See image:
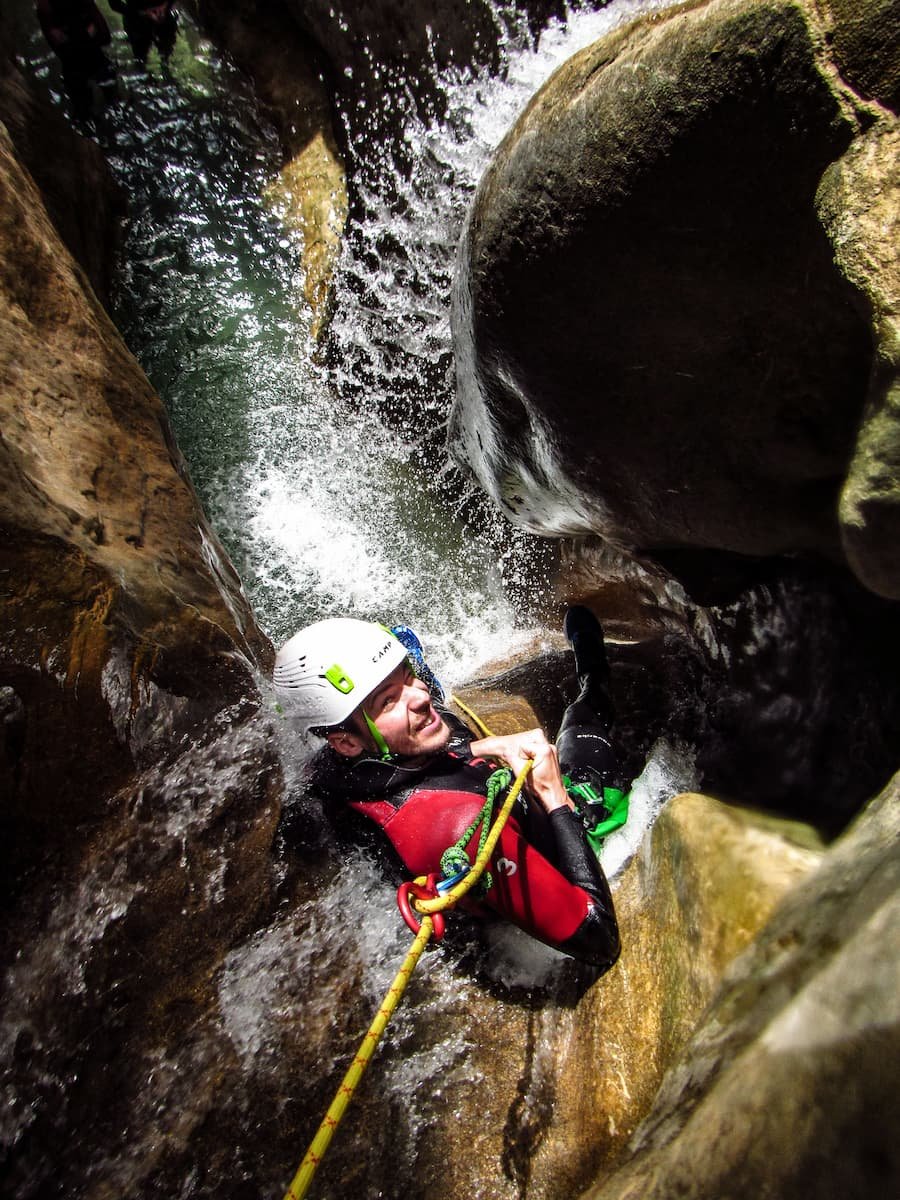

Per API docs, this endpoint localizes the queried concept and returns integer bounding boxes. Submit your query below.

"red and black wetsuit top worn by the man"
[316,709,619,970]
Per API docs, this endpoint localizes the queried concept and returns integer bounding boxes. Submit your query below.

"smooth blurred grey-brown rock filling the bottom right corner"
[586,779,900,1200]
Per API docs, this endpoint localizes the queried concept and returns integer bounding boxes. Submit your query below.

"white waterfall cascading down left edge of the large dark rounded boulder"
[332,0,691,427]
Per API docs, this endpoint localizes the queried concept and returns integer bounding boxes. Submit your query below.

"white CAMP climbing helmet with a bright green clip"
[274,617,407,730]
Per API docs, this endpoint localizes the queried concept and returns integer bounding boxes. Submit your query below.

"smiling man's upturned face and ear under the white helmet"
[329,662,450,756]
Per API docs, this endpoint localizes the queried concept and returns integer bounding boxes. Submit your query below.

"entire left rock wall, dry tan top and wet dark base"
[0,87,282,1196]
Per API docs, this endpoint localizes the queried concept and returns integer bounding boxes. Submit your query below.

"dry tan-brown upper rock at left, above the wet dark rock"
[0,121,270,878]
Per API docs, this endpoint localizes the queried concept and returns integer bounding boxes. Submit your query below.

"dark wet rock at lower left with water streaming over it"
[0,704,281,1200]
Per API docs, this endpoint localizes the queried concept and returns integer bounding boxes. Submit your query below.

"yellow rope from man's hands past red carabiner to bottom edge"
[284,758,532,1200]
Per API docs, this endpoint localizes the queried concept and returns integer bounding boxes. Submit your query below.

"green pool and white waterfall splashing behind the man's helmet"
[19,2,681,683]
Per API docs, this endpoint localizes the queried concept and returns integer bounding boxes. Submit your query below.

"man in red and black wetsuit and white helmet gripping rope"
[275,607,619,971]
